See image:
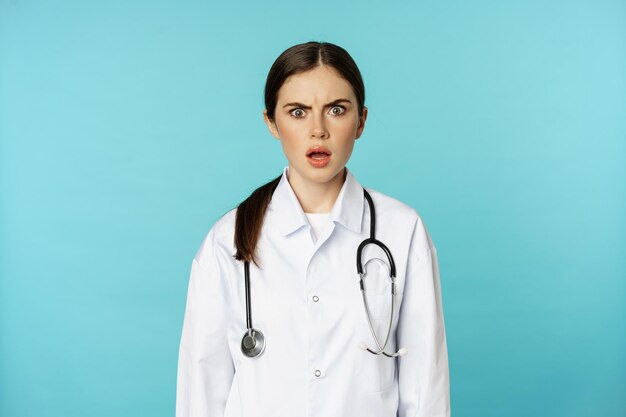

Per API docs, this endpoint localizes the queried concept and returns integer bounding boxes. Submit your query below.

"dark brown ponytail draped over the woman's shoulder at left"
[234,174,282,267]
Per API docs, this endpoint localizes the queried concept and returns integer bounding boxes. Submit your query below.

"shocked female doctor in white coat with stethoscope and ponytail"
[176,42,450,417]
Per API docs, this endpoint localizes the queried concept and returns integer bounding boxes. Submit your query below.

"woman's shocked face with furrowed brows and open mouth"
[263,66,367,184]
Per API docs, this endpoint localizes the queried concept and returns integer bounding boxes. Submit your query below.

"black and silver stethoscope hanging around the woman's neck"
[241,188,407,358]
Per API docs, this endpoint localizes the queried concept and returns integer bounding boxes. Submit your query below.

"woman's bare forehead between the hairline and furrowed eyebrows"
[278,66,354,102]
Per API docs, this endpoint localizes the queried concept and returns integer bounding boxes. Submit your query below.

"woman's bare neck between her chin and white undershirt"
[287,166,347,213]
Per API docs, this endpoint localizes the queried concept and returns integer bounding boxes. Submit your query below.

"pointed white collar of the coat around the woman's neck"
[268,165,365,236]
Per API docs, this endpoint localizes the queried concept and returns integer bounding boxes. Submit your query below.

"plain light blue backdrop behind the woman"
[0,0,626,417]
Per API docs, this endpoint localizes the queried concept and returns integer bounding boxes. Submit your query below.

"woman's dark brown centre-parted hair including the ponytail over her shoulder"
[234,41,365,267]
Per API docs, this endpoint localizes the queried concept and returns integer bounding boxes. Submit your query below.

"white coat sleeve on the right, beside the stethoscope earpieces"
[397,217,450,417]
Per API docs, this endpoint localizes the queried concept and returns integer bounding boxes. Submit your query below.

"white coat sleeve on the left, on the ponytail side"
[176,229,234,417]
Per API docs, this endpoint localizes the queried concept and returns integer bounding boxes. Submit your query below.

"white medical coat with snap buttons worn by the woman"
[176,166,450,417]
